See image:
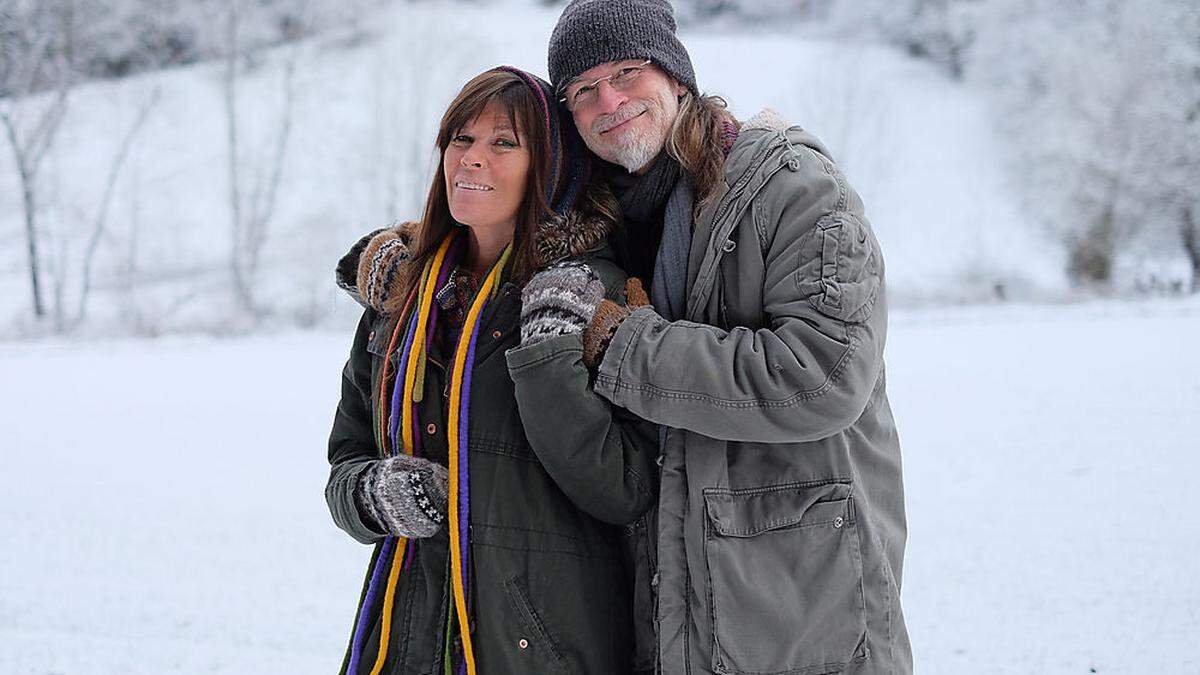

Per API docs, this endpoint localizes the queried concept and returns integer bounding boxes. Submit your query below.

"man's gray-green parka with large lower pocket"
[508,112,912,675]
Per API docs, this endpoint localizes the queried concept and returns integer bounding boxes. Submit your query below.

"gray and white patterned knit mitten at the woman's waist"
[354,455,450,539]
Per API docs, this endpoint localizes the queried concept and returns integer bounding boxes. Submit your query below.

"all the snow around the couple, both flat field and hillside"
[0,4,1200,675]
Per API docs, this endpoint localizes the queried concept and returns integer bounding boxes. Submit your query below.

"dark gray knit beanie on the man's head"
[548,0,700,95]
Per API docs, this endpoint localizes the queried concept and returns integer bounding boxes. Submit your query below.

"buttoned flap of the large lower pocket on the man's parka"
[704,482,853,537]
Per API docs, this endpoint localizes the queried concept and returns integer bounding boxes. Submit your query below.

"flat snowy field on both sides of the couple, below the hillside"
[0,303,1200,675]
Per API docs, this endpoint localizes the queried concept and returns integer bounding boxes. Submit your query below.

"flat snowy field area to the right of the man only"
[889,296,1200,674]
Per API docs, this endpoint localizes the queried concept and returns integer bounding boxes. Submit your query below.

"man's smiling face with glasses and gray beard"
[565,59,686,173]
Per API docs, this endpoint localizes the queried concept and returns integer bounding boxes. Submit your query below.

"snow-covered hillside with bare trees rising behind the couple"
[0,4,1063,334]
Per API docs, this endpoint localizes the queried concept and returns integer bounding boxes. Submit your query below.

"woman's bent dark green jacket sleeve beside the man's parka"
[506,265,659,525]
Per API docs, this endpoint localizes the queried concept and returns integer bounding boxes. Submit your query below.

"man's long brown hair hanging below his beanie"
[667,91,738,205]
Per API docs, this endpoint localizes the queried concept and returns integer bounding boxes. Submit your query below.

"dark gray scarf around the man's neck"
[612,151,692,321]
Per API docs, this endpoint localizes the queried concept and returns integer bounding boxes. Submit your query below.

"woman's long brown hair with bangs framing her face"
[404,68,552,294]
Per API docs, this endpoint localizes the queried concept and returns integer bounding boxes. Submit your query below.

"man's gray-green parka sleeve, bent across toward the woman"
[595,165,887,443]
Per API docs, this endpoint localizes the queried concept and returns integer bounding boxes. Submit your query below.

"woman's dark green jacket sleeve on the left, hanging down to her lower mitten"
[325,310,384,544]
